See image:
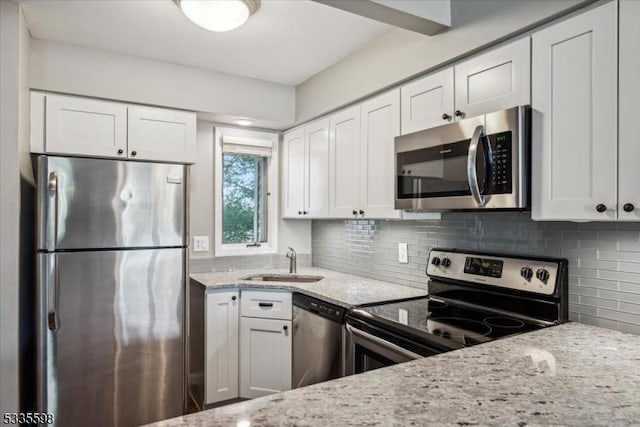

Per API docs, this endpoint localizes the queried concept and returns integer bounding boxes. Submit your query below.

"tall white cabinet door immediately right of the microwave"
[532,2,618,221]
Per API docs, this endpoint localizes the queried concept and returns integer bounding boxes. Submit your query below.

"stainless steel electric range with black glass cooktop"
[345,249,568,375]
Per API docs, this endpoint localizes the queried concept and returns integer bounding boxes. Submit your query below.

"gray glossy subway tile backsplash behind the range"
[312,212,640,334]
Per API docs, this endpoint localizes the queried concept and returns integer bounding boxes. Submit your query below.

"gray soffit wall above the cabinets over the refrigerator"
[31,39,295,128]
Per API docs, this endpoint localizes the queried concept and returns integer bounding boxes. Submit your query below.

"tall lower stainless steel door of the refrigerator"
[38,248,185,426]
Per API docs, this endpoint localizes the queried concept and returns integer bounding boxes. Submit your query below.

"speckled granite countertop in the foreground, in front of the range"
[148,323,640,427]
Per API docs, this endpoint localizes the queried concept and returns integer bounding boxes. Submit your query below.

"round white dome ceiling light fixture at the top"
[173,0,260,32]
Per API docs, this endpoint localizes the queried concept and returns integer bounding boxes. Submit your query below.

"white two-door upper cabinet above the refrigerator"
[31,92,196,163]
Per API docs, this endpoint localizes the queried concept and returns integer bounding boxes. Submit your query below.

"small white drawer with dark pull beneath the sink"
[240,291,291,320]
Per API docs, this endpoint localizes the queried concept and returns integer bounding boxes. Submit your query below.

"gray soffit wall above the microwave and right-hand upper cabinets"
[296,0,584,123]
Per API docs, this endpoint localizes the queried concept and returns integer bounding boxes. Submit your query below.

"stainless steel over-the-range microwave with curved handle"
[395,106,531,211]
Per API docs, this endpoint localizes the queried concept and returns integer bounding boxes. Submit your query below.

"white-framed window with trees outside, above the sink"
[214,128,278,256]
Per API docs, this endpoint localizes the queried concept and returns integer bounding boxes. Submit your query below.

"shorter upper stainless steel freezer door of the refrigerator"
[38,156,186,251]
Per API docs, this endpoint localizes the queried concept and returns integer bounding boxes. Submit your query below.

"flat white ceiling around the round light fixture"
[19,0,391,85]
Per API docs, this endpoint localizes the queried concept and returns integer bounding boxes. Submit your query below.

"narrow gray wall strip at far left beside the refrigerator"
[0,0,33,414]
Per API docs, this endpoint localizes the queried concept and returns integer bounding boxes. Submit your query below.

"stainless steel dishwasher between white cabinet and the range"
[293,293,345,388]
